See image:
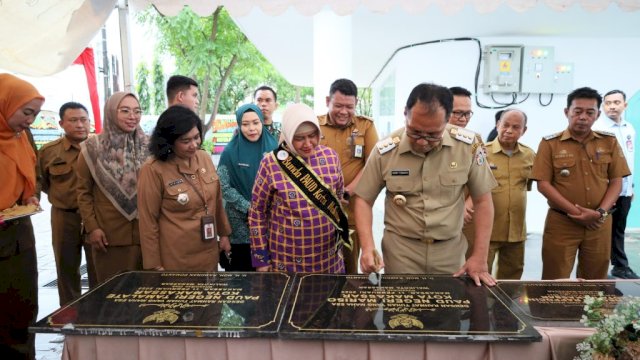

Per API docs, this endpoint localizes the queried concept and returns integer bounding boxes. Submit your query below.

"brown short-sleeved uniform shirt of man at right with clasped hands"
[531,129,630,209]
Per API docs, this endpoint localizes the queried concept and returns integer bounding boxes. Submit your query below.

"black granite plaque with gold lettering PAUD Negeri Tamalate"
[33,272,292,337]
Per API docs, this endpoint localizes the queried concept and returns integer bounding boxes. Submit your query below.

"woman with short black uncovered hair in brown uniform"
[138,105,231,272]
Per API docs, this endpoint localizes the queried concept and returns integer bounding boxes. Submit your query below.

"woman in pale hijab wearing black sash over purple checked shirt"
[249,104,349,273]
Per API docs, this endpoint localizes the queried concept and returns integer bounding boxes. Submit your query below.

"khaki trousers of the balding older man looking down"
[487,241,524,280]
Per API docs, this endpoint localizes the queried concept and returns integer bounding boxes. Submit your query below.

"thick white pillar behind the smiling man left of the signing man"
[313,11,353,114]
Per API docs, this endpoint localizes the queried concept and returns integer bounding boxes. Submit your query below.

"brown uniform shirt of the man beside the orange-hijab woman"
[38,136,80,210]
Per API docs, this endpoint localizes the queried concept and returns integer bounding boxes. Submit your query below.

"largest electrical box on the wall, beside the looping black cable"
[483,45,522,93]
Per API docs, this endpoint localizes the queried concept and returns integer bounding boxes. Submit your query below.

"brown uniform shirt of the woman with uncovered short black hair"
[138,151,231,271]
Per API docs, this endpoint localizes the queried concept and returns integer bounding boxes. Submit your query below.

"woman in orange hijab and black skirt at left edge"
[0,74,44,359]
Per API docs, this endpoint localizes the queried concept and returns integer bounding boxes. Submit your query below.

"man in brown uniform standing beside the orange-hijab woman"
[38,102,96,306]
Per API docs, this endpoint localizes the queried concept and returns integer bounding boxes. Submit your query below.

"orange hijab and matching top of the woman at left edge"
[0,74,44,210]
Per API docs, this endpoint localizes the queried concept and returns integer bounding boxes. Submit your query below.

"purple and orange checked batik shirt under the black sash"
[249,145,344,273]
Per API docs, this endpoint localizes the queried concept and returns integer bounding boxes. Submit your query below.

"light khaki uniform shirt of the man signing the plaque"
[356,125,496,240]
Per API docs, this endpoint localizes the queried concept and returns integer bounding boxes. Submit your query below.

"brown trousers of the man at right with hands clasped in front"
[542,209,611,280]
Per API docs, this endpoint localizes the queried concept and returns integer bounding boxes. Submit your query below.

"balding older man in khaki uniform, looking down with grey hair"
[487,109,536,280]
